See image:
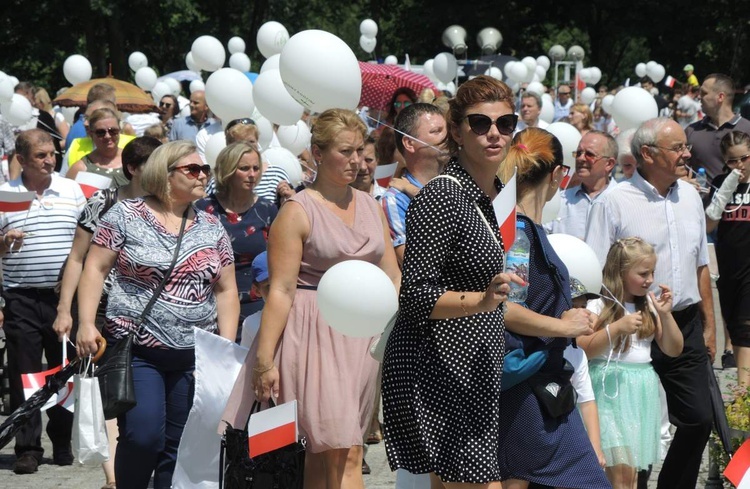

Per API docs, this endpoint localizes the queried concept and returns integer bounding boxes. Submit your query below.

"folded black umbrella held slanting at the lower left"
[0,336,107,449]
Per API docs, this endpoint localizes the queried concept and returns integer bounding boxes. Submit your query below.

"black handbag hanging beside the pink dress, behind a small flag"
[219,401,307,489]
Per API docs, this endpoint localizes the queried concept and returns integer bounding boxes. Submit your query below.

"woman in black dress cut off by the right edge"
[706,131,750,388]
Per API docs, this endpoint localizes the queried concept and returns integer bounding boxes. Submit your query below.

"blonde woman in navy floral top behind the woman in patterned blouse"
[196,142,278,332]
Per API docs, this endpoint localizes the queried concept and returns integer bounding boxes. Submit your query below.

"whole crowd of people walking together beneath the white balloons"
[0,61,750,489]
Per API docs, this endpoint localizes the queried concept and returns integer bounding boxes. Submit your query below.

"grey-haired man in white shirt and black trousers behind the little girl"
[586,118,716,488]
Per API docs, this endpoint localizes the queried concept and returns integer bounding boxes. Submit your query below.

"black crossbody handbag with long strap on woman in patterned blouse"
[94,207,190,419]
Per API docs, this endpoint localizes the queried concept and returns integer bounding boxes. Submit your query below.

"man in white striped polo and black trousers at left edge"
[0,129,86,474]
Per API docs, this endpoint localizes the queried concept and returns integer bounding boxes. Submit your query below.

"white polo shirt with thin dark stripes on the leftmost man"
[0,175,86,289]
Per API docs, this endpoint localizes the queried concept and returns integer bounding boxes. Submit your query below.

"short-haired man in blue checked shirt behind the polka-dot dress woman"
[381,103,448,266]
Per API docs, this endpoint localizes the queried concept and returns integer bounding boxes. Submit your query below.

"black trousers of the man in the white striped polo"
[3,288,75,459]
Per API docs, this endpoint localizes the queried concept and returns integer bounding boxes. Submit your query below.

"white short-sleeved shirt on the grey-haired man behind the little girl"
[586,171,708,311]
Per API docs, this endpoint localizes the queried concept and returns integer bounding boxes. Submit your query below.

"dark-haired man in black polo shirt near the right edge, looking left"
[685,73,750,182]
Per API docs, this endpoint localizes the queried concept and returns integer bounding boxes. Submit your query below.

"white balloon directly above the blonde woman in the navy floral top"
[206,68,255,121]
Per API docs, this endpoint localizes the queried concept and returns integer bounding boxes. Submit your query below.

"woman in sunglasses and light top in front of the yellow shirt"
[65,107,128,188]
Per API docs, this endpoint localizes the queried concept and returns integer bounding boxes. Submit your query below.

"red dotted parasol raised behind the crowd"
[359,61,441,110]
